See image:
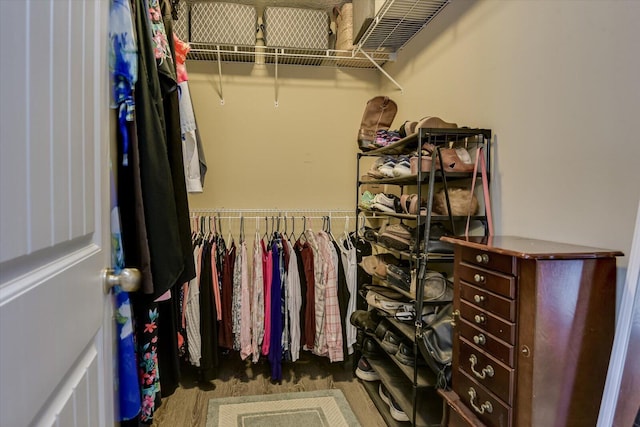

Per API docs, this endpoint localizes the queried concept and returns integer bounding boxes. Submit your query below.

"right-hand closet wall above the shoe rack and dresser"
[384,0,640,265]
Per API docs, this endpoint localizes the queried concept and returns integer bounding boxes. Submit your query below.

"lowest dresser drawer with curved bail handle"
[453,371,512,427]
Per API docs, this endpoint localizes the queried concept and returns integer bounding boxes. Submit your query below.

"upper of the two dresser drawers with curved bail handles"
[458,340,514,405]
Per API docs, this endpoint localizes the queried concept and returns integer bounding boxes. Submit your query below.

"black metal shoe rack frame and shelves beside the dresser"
[355,128,491,426]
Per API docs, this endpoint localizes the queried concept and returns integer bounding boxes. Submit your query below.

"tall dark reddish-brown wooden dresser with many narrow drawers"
[441,236,622,427]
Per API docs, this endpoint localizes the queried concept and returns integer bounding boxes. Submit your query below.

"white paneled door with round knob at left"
[0,0,114,427]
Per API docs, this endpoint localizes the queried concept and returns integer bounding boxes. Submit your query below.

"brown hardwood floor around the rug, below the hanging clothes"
[152,353,386,427]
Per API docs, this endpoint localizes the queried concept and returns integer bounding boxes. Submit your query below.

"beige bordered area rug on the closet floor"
[207,389,360,427]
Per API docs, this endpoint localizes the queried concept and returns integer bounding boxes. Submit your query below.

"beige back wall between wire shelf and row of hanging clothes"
[187,62,379,212]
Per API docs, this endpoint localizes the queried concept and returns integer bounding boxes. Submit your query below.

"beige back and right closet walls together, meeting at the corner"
[188,0,640,264]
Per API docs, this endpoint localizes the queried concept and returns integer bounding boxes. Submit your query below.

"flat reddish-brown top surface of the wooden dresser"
[441,236,624,259]
